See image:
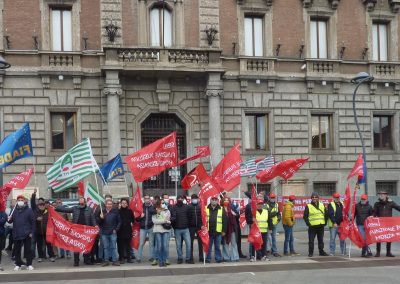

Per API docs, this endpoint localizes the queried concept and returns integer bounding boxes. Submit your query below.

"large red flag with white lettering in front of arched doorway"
[125,132,178,182]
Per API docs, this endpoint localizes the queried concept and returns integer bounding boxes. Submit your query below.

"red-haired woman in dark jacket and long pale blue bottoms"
[222,197,239,262]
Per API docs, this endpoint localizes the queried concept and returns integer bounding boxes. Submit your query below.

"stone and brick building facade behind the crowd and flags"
[0,0,400,197]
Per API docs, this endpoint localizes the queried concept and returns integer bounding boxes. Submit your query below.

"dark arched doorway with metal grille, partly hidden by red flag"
[141,113,187,195]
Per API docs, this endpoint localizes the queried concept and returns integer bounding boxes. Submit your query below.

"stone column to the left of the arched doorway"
[103,71,122,159]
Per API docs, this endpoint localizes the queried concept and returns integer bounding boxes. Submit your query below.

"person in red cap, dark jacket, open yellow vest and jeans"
[328,192,346,256]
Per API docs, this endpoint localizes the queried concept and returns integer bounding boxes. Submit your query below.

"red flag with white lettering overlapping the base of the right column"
[211,143,242,191]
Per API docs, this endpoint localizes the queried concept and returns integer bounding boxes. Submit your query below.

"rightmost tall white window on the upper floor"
[372,23,388,61]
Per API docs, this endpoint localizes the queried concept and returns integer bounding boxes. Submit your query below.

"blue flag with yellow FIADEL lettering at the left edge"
[0,123,33,169]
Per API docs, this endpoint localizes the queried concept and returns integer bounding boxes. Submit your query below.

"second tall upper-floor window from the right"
[310,19,328,58]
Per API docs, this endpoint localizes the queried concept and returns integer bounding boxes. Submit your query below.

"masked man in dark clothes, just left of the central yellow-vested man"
[189,194,204,262]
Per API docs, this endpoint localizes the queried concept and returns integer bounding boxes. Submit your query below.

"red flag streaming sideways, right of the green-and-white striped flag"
[256,157,310,182]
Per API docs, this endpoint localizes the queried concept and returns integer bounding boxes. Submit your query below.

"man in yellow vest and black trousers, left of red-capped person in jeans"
[303,192,328,257]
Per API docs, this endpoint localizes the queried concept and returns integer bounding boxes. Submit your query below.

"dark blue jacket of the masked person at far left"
[10,205,36,241]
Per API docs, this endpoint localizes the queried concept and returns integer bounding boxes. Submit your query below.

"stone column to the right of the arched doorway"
[206,73,223,167]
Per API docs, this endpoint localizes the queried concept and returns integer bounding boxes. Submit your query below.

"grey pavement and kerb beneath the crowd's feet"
[0,232,400,282]
